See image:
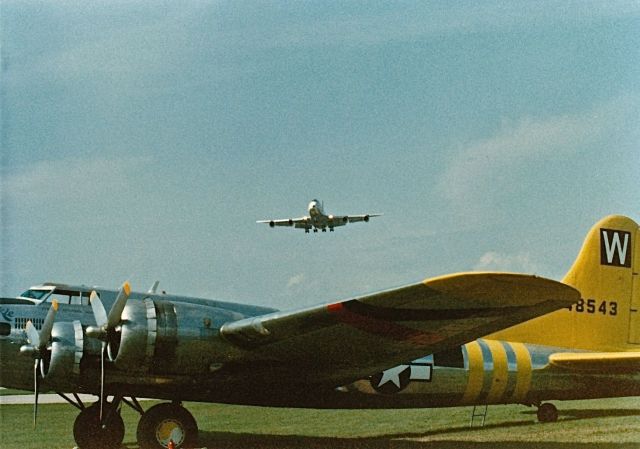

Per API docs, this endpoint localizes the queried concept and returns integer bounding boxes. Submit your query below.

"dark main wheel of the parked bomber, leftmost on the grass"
[73,403,124,449]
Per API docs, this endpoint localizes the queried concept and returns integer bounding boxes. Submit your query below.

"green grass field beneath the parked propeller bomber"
[0,398,640,449]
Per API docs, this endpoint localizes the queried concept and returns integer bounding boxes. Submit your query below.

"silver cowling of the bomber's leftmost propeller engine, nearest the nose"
[40,320,84,390]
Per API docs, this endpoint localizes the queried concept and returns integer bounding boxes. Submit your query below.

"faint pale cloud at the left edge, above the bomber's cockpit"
[2,156,149,232]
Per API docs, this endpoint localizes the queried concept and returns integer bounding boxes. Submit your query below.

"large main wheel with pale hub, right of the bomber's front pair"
[137,403,198,449]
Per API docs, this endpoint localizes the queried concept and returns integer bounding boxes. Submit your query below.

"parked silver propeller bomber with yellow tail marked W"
[0,216,640,449]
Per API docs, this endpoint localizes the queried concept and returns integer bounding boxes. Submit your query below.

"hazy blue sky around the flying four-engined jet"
[0,0,640,308]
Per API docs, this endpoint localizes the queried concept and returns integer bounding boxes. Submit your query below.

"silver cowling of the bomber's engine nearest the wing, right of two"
[107,298,157,372]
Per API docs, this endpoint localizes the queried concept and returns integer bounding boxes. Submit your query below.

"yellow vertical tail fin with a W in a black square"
[490,215,640,352]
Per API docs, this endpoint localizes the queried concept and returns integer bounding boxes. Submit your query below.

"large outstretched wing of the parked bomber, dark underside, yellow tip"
[220,273,580,386]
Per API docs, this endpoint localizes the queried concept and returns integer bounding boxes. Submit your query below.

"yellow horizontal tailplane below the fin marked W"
[549,352,640,374]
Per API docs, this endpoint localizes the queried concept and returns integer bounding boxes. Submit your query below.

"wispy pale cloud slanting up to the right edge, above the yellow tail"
[438,95,638,221]
